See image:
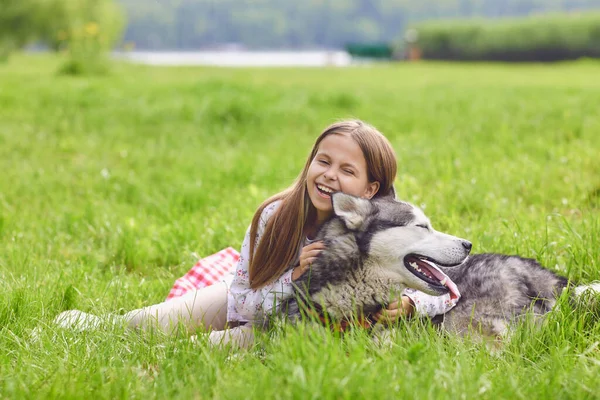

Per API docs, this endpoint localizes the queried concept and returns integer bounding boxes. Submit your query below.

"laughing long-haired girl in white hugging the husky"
[57,120,455,347]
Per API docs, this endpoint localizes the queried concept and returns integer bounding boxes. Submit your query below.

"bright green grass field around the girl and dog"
[0,55,600,399]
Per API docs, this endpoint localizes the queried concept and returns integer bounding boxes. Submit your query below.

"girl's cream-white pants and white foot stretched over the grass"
[55,282,254,348]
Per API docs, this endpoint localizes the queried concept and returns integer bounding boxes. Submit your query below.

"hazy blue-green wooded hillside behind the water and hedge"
[119,0,600,49]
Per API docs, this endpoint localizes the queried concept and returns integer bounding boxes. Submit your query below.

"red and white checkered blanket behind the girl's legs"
[167,247,240,300]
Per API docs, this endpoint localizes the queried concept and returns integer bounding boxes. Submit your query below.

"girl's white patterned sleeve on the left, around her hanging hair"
[227,202,294,321]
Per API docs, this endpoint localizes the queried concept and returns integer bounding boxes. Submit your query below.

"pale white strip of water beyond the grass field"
[114,50,352,67]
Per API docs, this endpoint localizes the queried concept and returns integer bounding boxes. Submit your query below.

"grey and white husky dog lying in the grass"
[283,193,596,336]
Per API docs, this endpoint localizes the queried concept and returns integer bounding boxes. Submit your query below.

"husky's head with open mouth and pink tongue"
[332,193,471,295]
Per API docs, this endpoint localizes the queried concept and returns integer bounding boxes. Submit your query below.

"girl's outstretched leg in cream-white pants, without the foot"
[123,282,227,333]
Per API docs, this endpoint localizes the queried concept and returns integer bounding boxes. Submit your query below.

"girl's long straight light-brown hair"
[249,120,397,289]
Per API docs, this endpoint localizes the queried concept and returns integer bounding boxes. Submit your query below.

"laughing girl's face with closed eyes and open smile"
[306,134,379,225]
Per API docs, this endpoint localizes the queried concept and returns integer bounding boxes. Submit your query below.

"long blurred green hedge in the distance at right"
[415,13,600,61]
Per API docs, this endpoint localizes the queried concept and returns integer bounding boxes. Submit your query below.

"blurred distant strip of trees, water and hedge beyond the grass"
[0,0,600,71]
